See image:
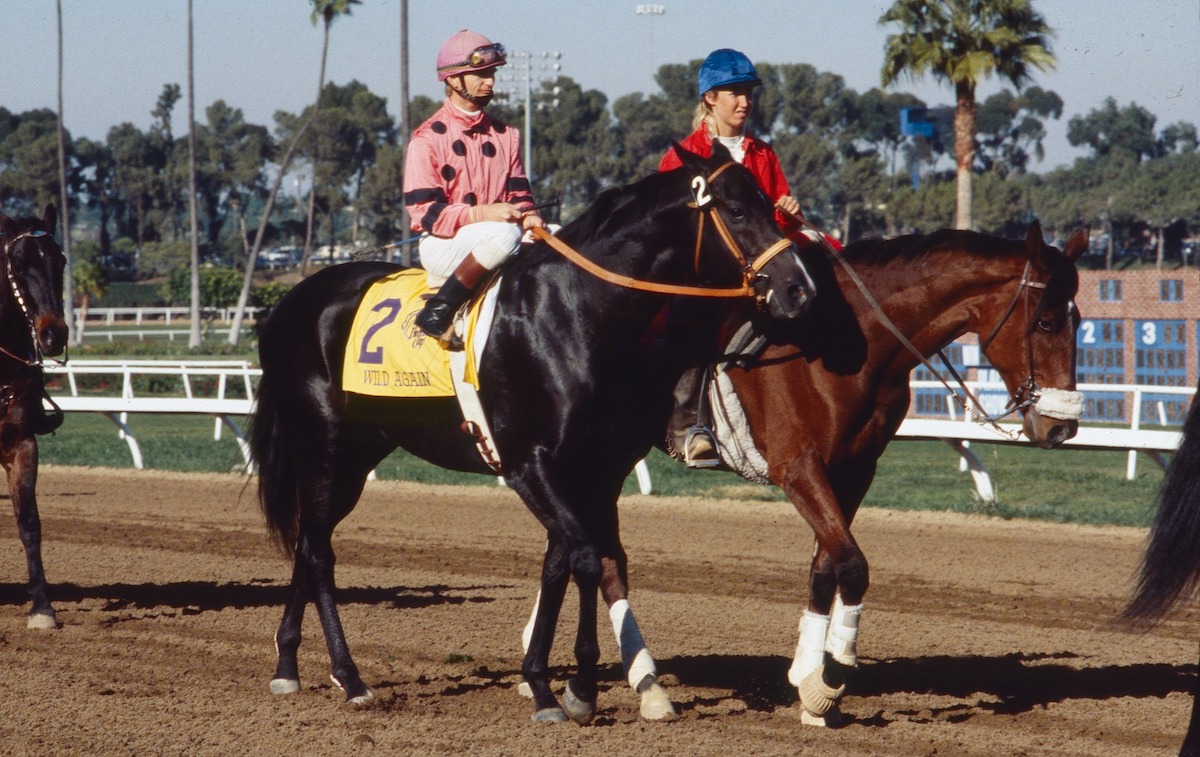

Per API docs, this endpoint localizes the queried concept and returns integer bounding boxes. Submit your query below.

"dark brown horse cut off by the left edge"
[0,204,67,629]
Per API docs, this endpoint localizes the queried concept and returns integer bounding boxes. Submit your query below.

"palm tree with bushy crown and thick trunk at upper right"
[880,0,1057,229]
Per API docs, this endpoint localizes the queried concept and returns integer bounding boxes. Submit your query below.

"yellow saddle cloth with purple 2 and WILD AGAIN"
[342,269,478,397]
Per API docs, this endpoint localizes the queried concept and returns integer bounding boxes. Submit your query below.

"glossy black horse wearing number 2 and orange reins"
[251,150,814,722]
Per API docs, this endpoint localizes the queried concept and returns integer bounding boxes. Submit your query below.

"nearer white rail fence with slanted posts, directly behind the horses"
[35,360,1195,501]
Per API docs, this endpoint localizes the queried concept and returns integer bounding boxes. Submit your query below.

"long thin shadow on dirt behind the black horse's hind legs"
[0,578,512,612]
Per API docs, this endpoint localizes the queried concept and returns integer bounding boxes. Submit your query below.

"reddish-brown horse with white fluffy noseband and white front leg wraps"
[544,222,1089,726]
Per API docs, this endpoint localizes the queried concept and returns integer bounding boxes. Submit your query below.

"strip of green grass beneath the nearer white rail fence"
[41,413,1163,525]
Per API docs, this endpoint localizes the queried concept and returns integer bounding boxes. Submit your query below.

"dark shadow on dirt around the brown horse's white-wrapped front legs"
[659,653,1196,725]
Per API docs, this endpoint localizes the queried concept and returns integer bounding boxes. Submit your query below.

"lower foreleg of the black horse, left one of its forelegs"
[521,539,570,722]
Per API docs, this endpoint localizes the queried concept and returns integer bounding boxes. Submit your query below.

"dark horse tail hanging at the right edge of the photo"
[1123,395,1200,625]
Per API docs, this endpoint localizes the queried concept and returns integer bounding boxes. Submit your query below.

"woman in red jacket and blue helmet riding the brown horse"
[659,48,841,468]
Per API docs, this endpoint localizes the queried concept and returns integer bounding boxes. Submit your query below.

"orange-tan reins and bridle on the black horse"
[533,161,792,311]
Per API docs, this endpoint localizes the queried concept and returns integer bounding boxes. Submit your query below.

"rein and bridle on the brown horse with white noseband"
[781,211,1046,441]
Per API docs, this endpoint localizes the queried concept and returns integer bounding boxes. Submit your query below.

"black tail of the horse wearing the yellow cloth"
[248,376,300,557]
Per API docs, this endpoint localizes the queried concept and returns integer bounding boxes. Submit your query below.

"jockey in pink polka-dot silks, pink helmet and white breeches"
[404,29,545,349]
